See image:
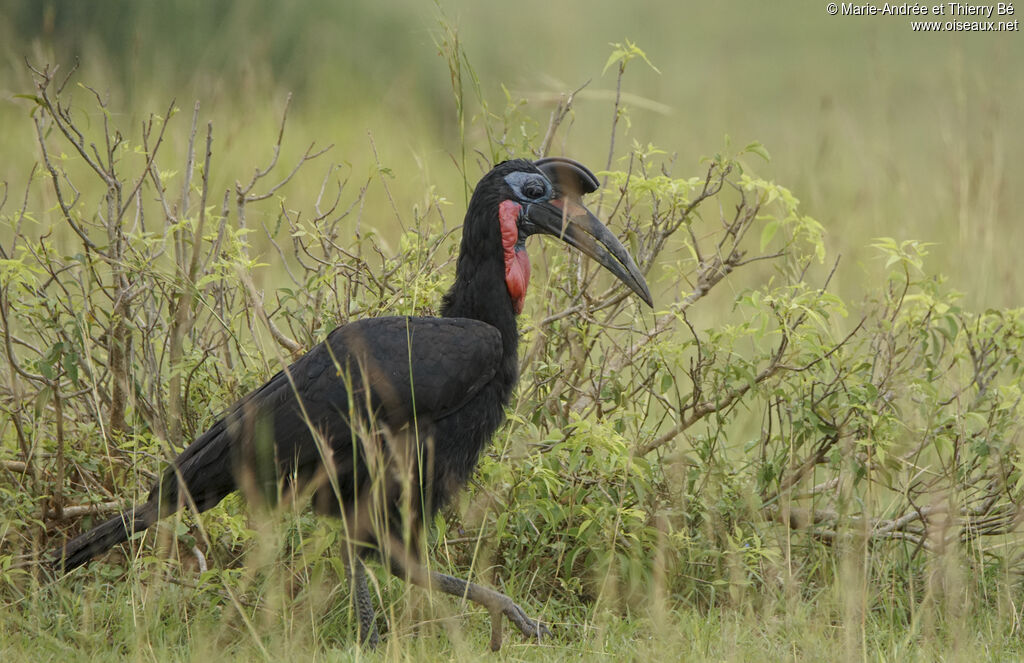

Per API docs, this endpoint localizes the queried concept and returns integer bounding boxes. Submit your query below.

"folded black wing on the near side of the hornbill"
[175,318,502,477]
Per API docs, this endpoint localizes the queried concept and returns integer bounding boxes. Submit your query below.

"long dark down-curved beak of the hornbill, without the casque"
[519,196,654,307]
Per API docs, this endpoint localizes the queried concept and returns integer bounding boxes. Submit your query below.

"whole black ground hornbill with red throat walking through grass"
[52,158,651,649]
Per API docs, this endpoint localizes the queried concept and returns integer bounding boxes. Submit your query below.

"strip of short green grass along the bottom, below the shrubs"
[0,570,1024,662]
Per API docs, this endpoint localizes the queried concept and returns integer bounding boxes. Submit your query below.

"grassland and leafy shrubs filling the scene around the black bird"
[0,2,1024,661]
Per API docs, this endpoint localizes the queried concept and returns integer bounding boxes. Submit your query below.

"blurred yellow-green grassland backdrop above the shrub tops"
[0,0,1024,309]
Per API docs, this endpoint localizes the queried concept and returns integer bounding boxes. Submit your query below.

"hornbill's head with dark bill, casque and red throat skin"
[467,157,653,314]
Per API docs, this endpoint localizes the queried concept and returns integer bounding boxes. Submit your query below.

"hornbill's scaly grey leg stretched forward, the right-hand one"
[387,537,551,652]
